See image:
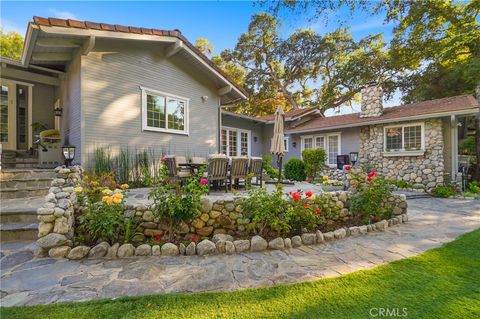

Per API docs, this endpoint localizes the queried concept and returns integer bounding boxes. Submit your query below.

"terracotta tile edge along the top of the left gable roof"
[33,16,248,96]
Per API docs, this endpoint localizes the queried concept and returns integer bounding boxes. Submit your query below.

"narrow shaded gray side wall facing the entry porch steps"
[60,56,83,163]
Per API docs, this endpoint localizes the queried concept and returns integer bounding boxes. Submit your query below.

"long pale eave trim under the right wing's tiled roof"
[286,108,480,134]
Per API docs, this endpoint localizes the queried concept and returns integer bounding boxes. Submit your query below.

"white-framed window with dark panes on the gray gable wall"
[142,88,189,134]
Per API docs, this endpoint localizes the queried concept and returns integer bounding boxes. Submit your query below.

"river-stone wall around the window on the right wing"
[359,119,444,188]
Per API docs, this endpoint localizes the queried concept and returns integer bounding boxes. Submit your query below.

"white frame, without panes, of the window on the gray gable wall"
[140,86,190,135]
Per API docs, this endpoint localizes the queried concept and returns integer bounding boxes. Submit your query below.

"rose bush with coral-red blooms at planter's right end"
[347,169,393,223]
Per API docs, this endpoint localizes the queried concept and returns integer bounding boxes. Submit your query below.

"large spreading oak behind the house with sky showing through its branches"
[221,14,395,115]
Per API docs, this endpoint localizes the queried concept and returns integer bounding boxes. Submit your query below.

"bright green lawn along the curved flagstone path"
[0,229,480,319]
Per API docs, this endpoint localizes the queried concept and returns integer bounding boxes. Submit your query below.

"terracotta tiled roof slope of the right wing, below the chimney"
[289,95,479,132]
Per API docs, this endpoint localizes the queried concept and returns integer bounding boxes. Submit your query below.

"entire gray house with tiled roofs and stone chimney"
[0,17,479,186]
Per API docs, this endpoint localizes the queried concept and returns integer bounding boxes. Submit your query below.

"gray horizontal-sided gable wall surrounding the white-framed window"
[82,40,219,165]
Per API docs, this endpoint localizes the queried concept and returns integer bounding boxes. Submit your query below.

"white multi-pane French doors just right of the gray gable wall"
[220,127,251,156]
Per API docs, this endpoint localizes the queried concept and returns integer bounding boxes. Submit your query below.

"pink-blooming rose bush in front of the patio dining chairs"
[148,166,208,240]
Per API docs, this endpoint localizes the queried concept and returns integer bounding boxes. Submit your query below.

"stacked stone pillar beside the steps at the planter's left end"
[37,166,83,257]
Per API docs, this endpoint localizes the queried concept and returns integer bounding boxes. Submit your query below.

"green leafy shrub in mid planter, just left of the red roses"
[241,184,292,236]
